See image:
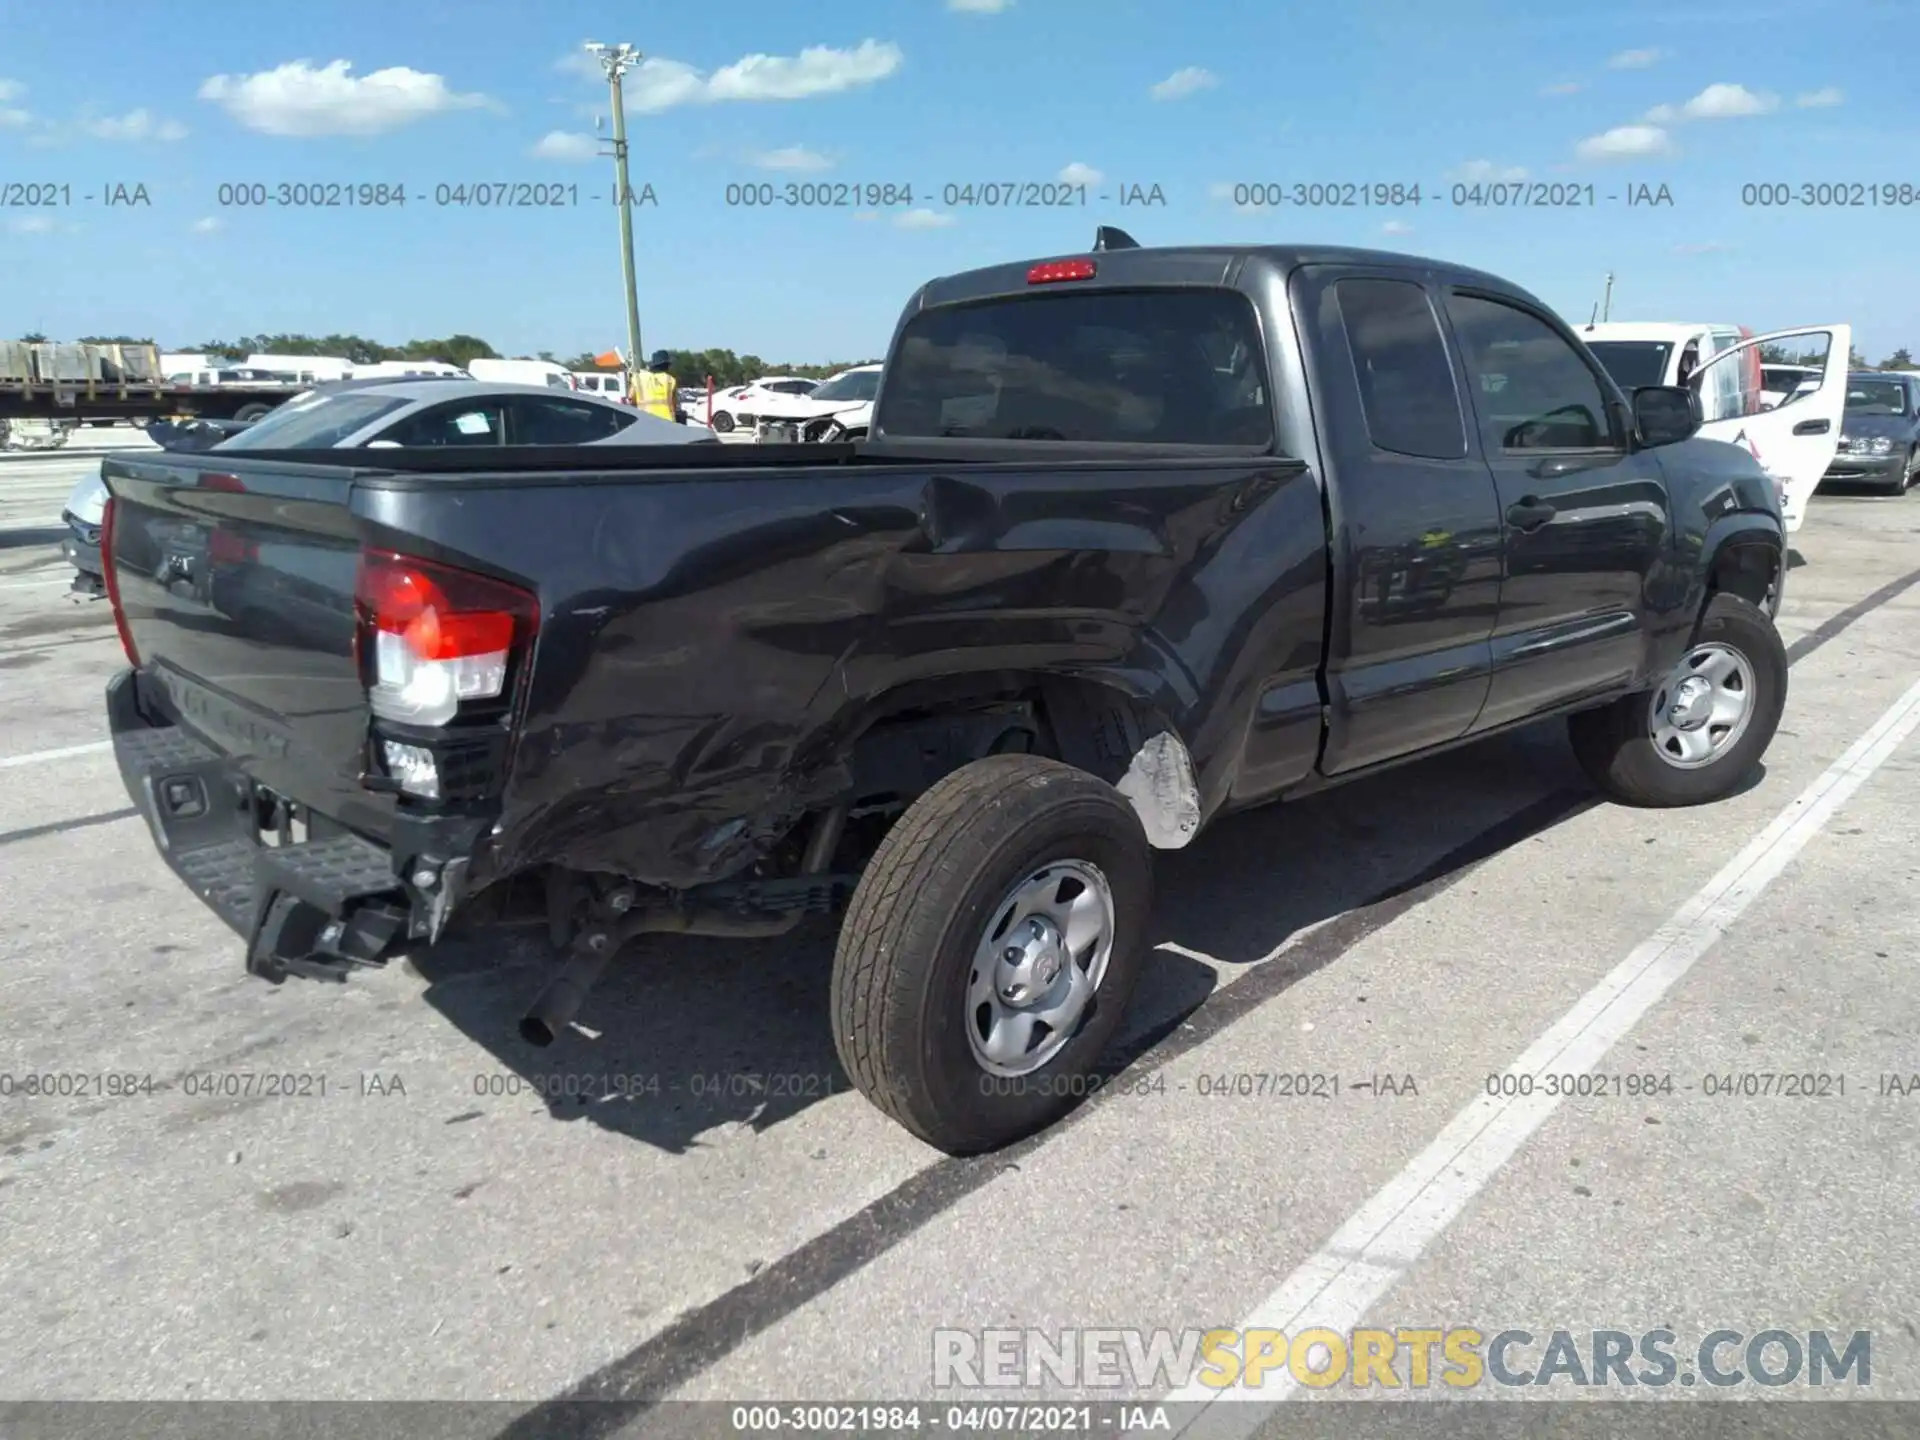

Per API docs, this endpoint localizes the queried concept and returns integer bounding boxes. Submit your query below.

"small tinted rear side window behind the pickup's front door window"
[1334,280,1467,461]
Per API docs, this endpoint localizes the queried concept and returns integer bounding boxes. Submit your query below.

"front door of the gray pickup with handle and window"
[1446,288,1668,730]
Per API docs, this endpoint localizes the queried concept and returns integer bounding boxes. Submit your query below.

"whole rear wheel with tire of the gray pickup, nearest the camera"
[831,755,1152,1154]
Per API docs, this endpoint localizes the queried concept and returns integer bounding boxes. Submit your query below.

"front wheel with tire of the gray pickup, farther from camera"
[1567,595,1788,806]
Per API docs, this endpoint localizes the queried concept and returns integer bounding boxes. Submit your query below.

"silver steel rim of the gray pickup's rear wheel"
[966,860,1114,1077]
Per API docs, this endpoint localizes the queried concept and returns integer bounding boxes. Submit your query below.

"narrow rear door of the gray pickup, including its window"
[1294,265,1500,774]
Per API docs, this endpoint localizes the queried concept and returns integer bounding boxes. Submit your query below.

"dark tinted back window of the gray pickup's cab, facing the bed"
[876,288,1273,449]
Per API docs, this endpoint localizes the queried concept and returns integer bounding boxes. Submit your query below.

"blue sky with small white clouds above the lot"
[0,0,1920,361]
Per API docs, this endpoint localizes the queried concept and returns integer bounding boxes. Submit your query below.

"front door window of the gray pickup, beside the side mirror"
[1448,294,1620,449]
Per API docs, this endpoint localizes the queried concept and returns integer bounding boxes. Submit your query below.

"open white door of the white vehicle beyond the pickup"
[1693,324,1853,532]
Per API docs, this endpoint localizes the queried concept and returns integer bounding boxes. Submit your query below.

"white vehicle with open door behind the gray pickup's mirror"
[1576,321,1853,534]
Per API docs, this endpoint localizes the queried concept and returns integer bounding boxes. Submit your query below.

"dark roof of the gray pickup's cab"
[908,244,1540,309]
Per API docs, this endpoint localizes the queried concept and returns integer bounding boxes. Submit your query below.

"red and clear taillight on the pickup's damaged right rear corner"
[353,551,540,726]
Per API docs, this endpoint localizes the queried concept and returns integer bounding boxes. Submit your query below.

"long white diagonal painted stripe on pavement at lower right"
[1169,684,1920,1440]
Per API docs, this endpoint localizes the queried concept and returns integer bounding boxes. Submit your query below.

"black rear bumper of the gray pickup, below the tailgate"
[108,670,449,983]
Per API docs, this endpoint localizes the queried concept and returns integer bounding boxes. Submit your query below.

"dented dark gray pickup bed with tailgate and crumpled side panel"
[104,442,1325,948]
